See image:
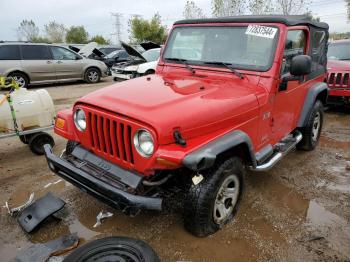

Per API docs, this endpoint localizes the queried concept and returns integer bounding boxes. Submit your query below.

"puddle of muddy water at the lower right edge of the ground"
[306,200,350,257]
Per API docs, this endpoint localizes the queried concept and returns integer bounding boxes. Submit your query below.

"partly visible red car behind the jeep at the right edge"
[327,39,350,104]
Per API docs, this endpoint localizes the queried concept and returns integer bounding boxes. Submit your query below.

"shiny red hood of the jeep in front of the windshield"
[77,75,258,144]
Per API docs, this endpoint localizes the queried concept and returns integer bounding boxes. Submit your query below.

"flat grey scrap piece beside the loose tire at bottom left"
[13,233,79,262]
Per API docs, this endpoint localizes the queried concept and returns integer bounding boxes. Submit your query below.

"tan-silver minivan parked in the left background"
[0,42,108,87]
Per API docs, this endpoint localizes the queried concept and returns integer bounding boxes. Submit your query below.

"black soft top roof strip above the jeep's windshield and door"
[174,15,329,30]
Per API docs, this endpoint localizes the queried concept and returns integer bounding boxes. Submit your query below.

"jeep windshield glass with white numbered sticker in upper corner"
[163,25,278,71]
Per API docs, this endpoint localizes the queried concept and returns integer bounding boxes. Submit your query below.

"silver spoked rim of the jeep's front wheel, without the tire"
[213,173,240,224]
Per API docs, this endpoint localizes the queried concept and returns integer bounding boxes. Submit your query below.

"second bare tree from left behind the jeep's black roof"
[212,0,245,17]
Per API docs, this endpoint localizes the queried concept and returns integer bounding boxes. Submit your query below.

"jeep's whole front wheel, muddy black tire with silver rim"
[184,157,245,237]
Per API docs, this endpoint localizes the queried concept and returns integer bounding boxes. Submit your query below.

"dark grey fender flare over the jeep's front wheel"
[182,130,256,171]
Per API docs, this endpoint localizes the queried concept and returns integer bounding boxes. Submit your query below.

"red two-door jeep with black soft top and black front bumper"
[45,16,328,236]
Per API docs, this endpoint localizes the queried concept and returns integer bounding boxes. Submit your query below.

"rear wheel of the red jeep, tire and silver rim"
[297,100,324,151]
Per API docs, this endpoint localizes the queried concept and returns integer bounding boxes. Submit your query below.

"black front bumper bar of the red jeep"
[44,144,162,211]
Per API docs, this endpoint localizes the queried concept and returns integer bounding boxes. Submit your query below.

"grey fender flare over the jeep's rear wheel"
[297,82,329,127]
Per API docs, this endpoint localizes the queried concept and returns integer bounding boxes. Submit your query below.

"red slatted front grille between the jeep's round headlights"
[87,111,134,166]
